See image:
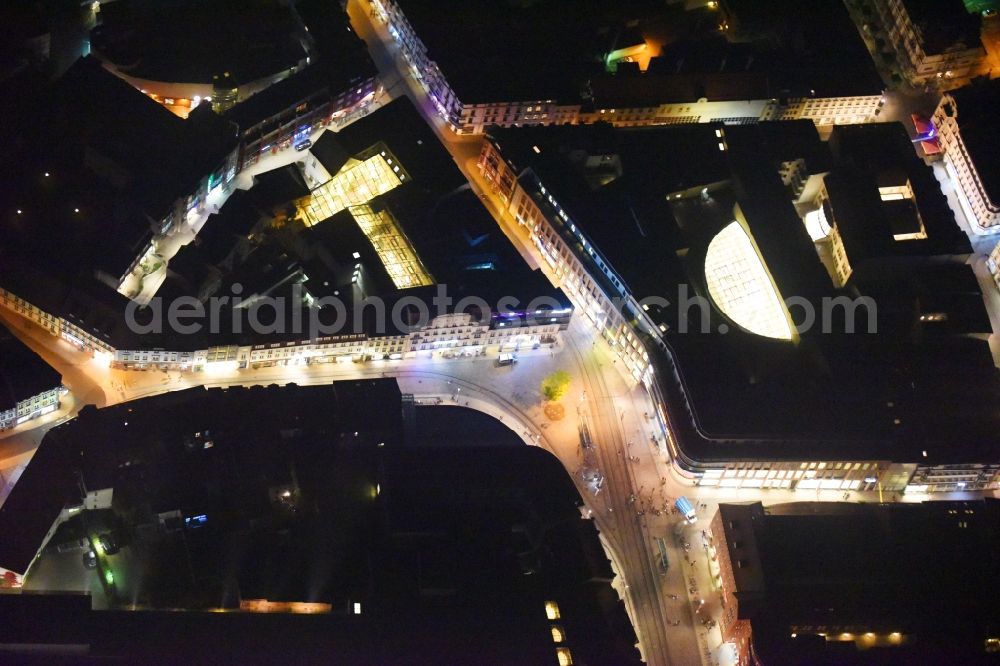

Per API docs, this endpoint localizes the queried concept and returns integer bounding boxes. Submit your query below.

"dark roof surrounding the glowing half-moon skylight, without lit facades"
[490,121,1000,462]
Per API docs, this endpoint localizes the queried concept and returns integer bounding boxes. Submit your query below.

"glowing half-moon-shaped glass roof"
[705,221,792,340]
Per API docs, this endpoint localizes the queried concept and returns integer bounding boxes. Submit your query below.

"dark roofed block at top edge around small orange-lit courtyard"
[399,0,882,107]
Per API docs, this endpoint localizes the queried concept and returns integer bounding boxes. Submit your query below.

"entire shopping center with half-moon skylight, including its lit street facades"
[479,121,1000,492]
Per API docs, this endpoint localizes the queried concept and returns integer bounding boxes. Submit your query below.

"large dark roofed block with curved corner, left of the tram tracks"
[0,380,638,664]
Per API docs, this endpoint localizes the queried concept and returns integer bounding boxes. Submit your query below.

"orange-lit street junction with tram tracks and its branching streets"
[0,0,996,664]
